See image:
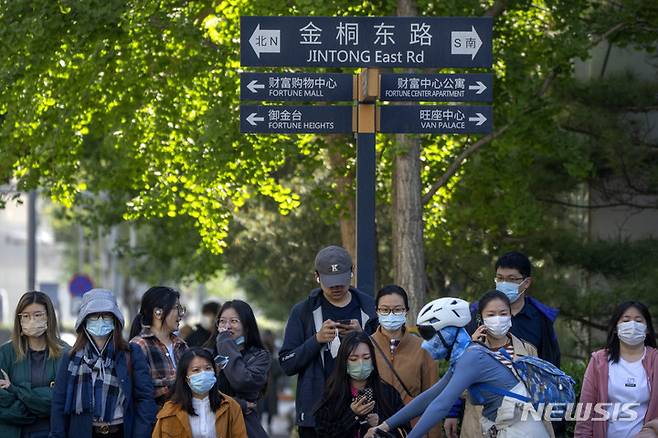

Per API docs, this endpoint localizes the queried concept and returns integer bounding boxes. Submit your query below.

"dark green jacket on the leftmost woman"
[0,341,68,438]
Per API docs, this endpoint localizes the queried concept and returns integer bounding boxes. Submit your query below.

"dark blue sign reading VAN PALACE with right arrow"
[379,105,493,134]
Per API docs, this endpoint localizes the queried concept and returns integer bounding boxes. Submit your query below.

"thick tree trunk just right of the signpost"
[391,0,425,325]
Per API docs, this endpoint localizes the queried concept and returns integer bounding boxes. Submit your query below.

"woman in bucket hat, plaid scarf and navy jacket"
[50,289,156,438]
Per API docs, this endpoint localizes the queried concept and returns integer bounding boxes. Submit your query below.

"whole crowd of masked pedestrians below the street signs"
[0,246,658,438]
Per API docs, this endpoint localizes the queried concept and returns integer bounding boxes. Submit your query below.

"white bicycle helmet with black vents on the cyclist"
[416,297,471,339]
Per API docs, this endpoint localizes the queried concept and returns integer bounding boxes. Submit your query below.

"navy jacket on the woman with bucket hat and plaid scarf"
[49,344,158,438]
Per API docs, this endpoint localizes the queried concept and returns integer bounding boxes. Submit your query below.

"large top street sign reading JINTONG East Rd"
[240,17,493,68]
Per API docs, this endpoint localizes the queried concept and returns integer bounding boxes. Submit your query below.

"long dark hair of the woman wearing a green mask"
[317,331,395,418]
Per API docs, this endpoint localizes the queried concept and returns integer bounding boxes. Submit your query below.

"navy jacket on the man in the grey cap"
[279,288,376,427]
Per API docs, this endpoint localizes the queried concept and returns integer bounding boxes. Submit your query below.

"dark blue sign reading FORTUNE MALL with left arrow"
[240,73,354,102]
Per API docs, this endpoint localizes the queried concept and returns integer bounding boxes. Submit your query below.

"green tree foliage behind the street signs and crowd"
[0,0,658,346]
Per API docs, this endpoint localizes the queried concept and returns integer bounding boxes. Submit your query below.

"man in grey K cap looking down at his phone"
[279,246,375,438]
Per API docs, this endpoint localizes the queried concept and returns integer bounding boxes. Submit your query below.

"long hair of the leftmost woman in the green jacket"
[11,291,62,361]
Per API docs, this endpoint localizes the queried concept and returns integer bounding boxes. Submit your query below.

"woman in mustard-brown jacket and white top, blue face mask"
[152,347,247,438]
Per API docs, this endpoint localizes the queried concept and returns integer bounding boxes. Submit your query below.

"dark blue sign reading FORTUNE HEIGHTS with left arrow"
[240,105,353,134]
